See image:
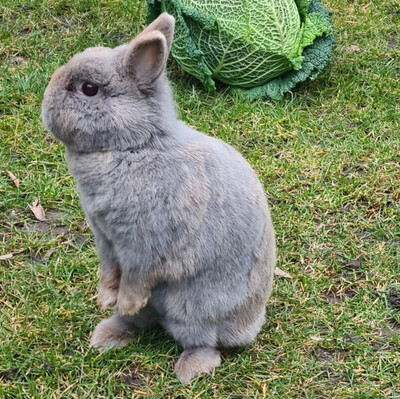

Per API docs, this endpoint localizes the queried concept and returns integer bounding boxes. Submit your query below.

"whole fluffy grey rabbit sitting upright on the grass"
[42,13,275,383]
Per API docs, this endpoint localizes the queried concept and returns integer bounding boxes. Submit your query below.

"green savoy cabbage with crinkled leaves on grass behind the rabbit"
[147,0,333,98]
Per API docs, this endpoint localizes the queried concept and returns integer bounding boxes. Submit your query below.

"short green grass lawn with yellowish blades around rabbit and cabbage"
[0,0,400,399]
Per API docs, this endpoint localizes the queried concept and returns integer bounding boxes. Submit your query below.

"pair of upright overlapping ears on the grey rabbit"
[124,13,174,90]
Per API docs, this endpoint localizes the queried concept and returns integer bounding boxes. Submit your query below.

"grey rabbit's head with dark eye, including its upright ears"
[42,13,175,152]
